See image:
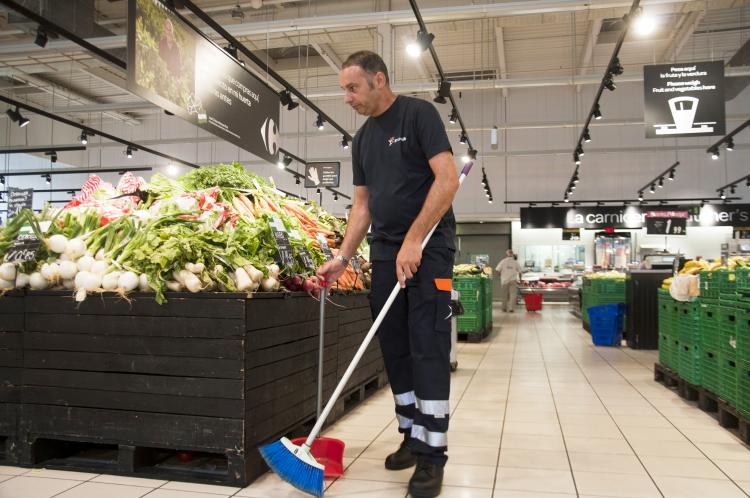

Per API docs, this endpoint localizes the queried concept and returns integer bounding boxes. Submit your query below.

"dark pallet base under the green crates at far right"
[654,363,750,444]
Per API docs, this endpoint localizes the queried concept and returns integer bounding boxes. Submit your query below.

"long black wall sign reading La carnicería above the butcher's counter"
[521,204,750,229]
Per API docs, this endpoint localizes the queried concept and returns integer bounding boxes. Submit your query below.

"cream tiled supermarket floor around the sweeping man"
[0,306,750,498]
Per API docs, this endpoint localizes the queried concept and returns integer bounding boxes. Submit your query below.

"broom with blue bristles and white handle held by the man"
[260,161,474,498]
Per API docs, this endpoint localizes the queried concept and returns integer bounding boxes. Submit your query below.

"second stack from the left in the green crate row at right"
[673,301,701,386]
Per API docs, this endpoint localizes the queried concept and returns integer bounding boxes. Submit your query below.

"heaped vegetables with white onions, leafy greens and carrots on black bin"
[0,163,367,303]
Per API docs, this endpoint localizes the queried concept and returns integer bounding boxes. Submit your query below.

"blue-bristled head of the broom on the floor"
[260,438,323,498]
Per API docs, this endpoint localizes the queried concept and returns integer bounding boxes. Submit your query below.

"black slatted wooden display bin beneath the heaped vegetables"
[0,292,384,486]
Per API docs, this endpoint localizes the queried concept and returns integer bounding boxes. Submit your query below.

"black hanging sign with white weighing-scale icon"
[643,61,726,138]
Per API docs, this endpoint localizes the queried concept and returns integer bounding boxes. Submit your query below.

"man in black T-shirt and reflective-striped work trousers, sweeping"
[318,51,459,498]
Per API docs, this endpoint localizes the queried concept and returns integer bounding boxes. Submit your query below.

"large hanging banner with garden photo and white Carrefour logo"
[128,0,279,162]
